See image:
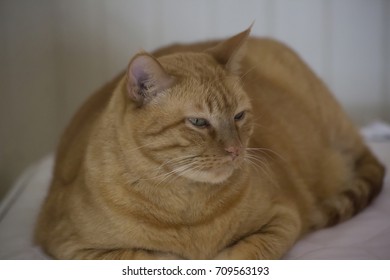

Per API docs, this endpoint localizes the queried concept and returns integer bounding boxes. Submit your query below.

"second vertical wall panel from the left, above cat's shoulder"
[54,0,108,124]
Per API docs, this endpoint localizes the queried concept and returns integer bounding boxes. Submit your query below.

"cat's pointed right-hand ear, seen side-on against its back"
[206,25,252,74]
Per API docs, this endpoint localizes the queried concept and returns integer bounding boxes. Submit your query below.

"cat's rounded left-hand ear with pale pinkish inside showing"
[126,53,175,106]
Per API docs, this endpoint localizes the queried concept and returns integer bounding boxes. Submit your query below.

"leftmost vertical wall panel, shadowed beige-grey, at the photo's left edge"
[0,0,59,197]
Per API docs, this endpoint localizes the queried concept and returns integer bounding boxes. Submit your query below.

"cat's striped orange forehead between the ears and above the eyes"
[161,53,250,115]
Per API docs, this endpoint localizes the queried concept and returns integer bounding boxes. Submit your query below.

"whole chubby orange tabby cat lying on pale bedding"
[36,28,385,259]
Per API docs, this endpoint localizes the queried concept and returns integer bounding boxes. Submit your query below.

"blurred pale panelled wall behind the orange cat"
[0,0,390,200]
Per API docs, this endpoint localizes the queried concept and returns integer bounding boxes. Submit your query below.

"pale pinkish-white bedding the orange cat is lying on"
[0,131,390,260]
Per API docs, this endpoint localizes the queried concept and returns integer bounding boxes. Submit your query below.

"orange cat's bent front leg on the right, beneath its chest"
[214,211,301,260]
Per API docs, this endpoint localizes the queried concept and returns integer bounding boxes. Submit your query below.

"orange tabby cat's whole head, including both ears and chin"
[126,29,252,184]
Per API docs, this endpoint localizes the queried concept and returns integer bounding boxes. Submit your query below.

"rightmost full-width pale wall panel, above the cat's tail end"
[332,0,385,122]
